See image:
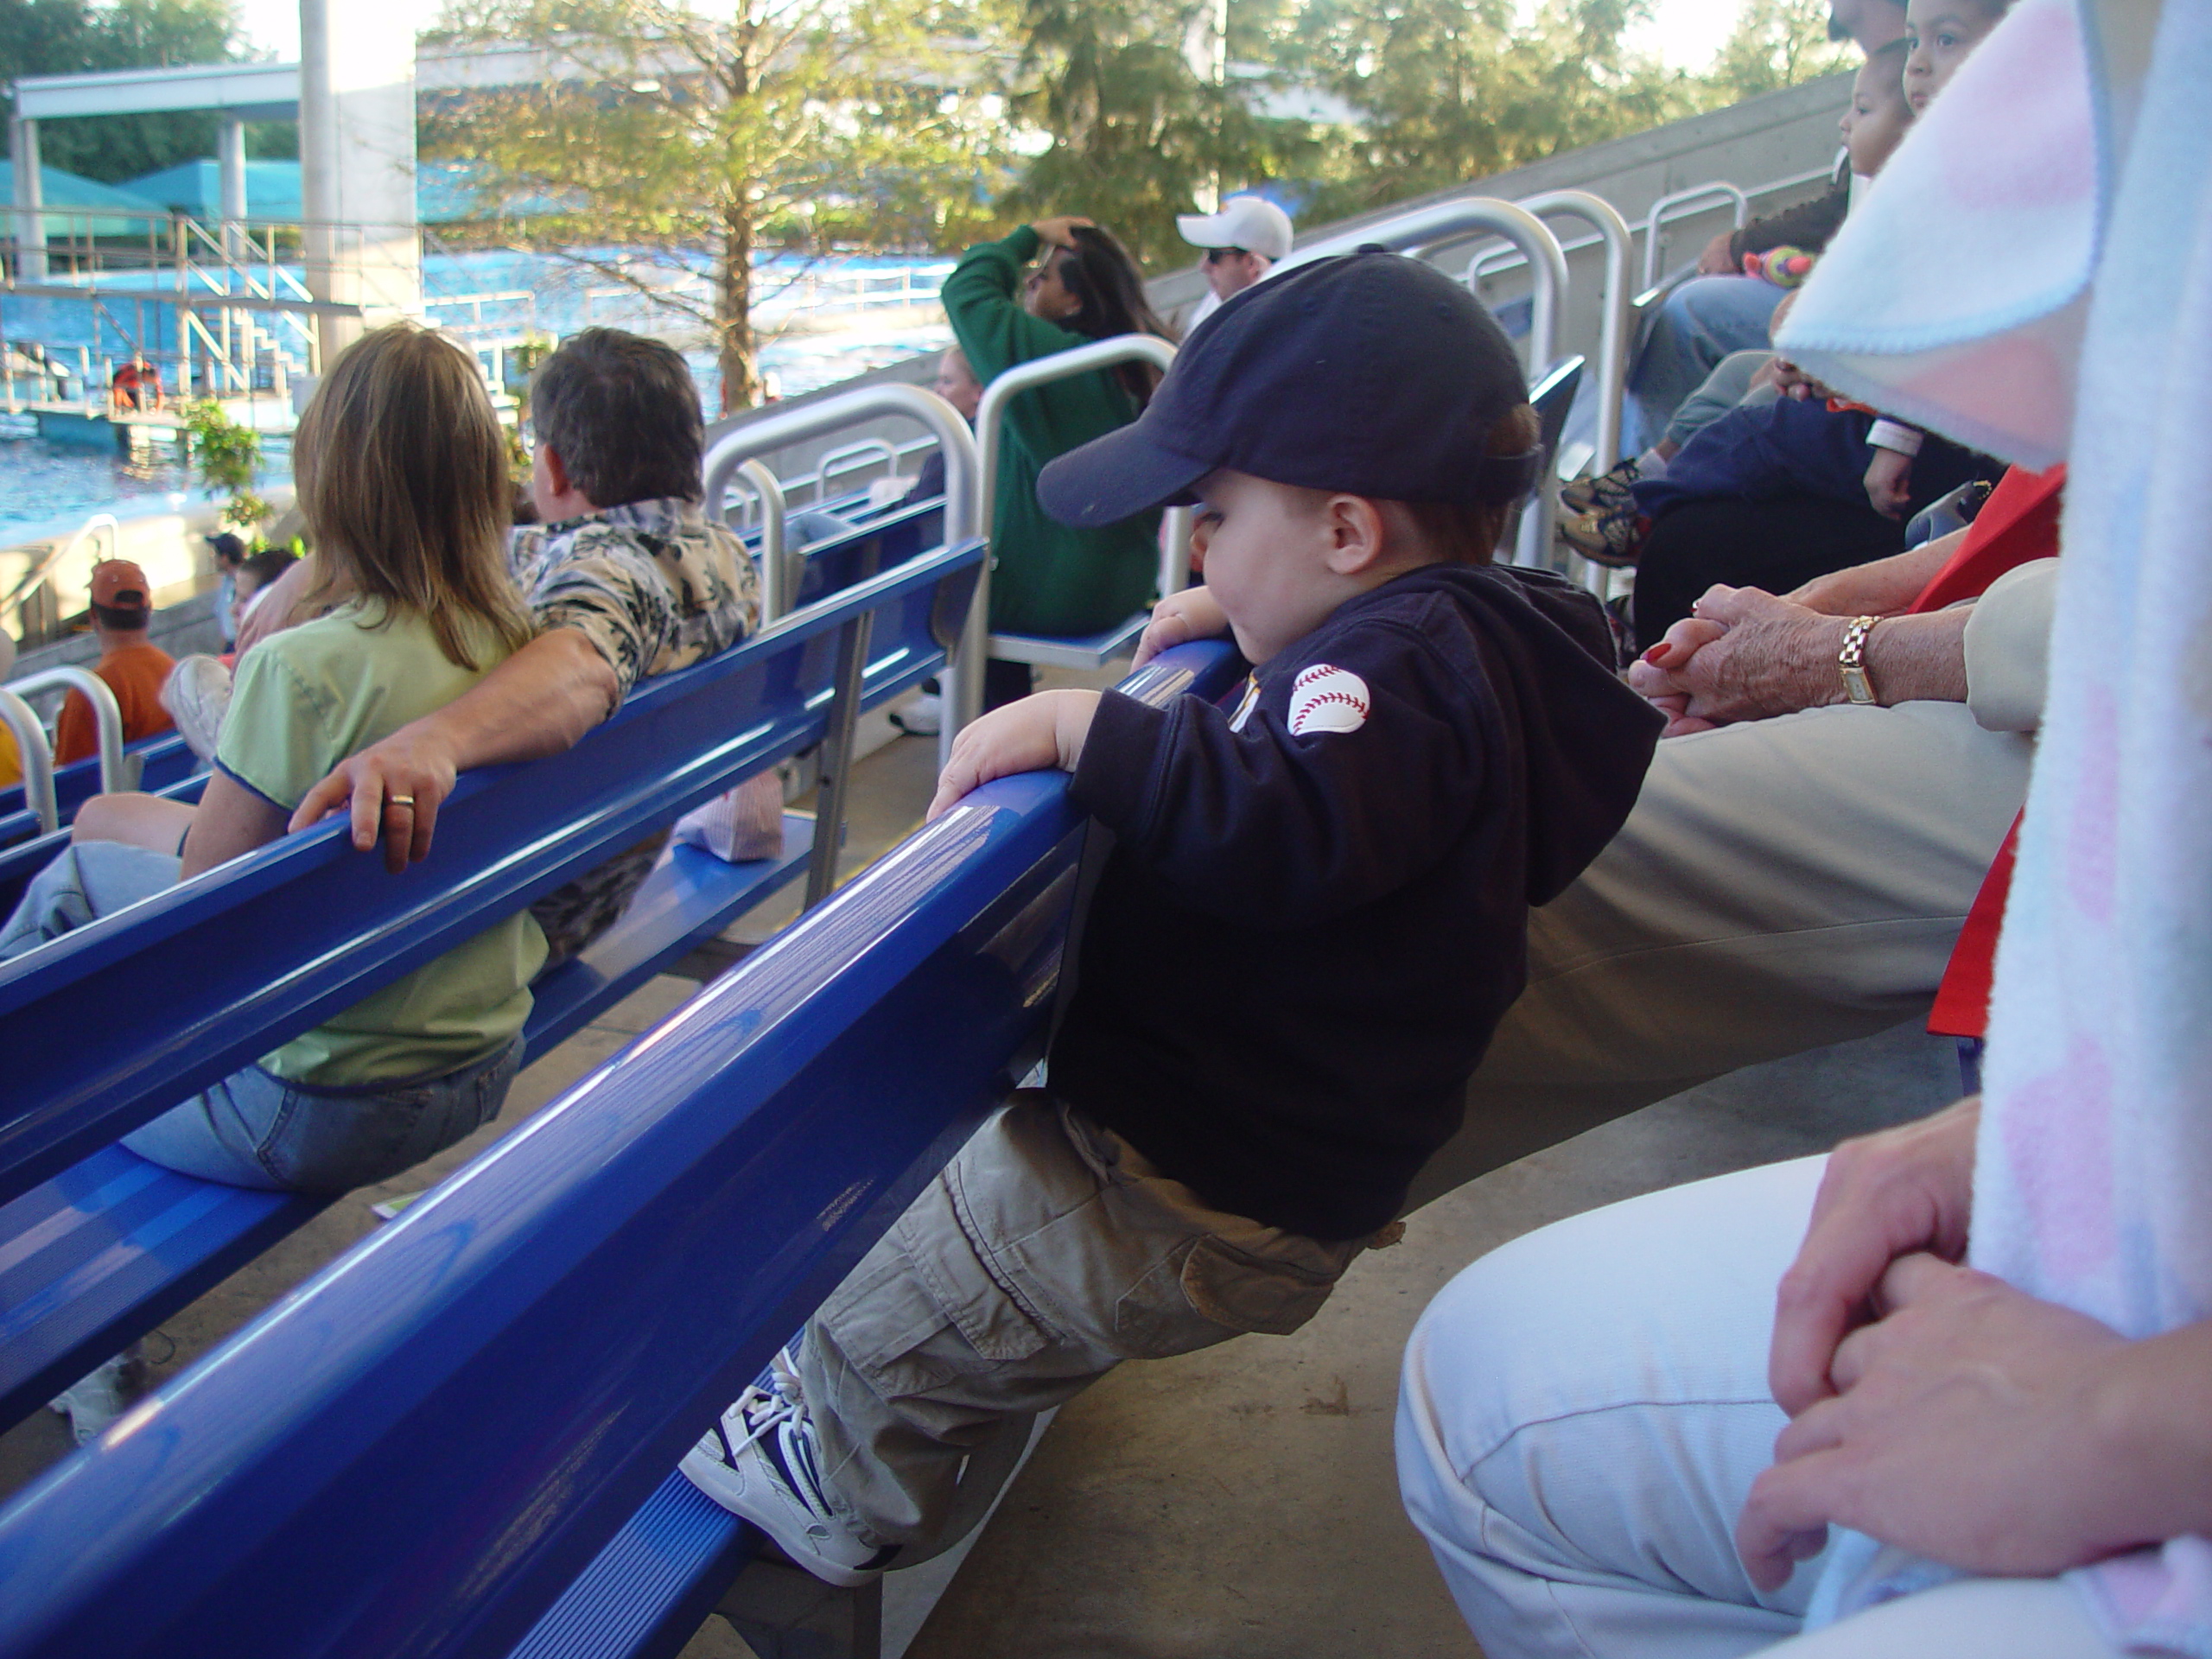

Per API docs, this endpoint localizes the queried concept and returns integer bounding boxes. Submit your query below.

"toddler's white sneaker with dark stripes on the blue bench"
[681,1350,898,1588]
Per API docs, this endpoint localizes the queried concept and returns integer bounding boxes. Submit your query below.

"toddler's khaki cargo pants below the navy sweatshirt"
[798,1090,1365,1546]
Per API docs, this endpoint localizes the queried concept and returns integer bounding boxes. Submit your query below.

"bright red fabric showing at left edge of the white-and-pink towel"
[1911,465,2066,1038]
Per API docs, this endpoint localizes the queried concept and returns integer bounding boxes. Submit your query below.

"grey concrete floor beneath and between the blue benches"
[0,690,1958,1659]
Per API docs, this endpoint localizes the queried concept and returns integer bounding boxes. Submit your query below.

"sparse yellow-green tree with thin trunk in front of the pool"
[425,0,1004,407]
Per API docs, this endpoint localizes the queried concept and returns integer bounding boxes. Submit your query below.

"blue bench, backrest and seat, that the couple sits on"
[0,542,982,1418]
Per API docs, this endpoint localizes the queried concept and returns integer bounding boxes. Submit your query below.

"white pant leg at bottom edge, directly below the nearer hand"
[1765,1580,2119,1659]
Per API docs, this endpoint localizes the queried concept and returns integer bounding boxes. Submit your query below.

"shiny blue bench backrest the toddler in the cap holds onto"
[0,644,1228,1659]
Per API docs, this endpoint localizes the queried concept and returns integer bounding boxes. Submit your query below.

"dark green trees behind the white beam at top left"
[0,0,296,183]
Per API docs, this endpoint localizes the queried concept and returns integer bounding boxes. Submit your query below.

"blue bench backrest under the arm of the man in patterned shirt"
[0,542,982,1201]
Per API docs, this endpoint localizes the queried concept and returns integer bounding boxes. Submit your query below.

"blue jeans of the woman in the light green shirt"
[0,841,522,1192]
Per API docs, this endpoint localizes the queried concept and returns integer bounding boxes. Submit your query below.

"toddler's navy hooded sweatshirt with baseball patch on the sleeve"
[1051,564,1662,1239]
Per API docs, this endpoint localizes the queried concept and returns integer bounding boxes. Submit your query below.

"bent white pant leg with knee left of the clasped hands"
[1398,1157,1825,1659]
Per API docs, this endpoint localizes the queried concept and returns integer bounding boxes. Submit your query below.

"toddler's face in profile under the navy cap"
[1190,469,1344,664]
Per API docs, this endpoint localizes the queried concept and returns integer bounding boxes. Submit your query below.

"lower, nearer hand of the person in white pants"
[1737,1255,2132,1591]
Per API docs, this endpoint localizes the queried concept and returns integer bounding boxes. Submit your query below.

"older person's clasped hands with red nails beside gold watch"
[1628,586,1849,734]
